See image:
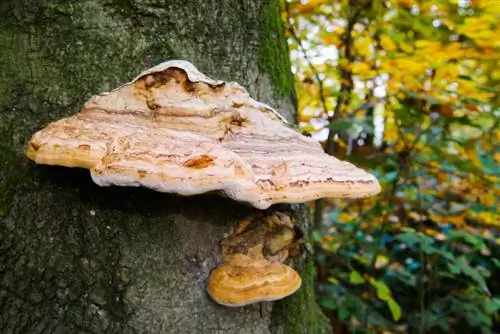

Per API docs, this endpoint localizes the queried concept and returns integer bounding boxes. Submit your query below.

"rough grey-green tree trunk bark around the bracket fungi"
[0,0,328,333]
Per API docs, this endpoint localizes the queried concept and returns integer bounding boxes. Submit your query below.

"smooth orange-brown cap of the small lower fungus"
[207,254,302,307]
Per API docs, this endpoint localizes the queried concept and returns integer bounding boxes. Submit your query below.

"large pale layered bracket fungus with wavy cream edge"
[27,60,380,209]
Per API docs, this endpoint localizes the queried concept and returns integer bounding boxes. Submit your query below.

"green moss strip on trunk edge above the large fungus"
[259,0,293,97]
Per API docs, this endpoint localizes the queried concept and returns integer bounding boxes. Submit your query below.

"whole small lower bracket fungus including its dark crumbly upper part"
[207,212,302,306]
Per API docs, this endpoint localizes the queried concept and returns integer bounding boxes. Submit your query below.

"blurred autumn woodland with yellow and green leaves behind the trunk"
[282,0,500,333]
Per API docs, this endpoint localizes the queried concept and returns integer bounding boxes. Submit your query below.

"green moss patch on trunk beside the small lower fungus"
[273,257,331,334]
